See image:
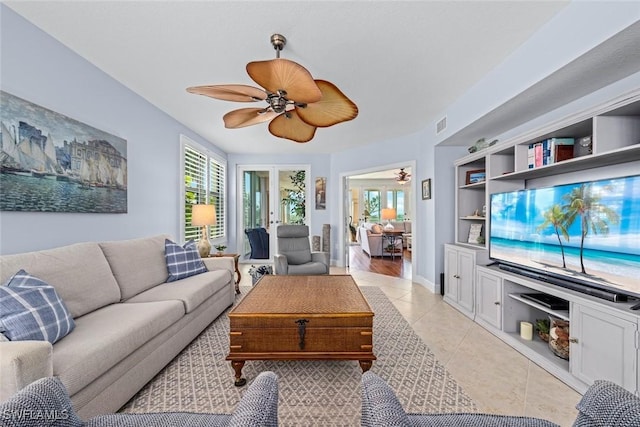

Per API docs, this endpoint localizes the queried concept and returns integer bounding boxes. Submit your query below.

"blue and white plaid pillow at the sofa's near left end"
[0,270,76,344]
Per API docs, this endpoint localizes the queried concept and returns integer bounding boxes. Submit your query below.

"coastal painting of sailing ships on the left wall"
[0,91,127,213]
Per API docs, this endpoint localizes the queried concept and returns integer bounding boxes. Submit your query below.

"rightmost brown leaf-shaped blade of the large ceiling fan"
[296,80,358,127]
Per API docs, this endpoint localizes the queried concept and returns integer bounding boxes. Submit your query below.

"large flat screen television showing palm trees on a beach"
[489,175,640,301]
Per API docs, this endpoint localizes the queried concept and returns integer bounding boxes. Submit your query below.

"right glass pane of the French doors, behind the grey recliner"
[278,169,306,224]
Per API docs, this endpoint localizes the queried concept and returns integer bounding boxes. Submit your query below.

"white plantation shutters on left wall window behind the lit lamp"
[182,137,227,241]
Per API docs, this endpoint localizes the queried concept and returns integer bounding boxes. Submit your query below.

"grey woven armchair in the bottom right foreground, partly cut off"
[361,371,640,427]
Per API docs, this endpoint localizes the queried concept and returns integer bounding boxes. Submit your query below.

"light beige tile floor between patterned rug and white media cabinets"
[241,265,581,426]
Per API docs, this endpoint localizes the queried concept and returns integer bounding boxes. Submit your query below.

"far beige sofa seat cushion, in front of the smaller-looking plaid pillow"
[127,270,231,313]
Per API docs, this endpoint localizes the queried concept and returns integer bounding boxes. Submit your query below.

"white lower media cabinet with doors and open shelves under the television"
[475,266,640,393]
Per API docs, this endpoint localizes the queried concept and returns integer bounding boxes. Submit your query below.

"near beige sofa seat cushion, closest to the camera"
[53,301,184,396]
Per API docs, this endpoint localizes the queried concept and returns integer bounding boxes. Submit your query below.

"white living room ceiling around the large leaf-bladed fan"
[5,1,567,153]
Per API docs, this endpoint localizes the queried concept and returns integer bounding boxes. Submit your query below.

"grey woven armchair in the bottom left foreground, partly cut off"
[0,371,278,427]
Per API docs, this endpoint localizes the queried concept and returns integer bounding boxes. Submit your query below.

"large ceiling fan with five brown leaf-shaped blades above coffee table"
[187,34,358,142]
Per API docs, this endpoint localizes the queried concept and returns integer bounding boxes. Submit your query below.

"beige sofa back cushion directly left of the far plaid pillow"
[99,235,169,300]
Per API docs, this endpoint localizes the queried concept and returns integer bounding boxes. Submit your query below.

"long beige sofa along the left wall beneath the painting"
[0,235,235,418]
